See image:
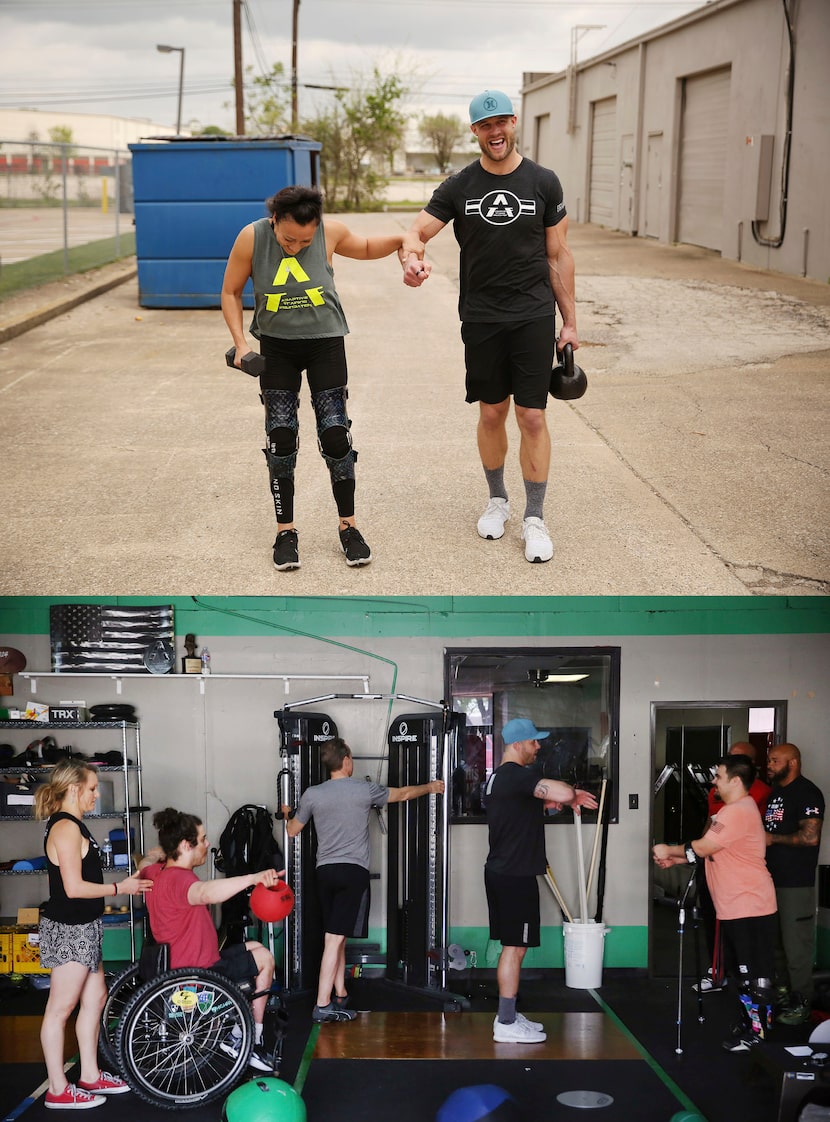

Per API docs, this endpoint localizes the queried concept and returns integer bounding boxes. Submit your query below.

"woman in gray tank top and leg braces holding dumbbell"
[222,186,403,571]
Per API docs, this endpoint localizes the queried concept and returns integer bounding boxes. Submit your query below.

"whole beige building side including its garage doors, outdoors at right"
[520,0,830,281]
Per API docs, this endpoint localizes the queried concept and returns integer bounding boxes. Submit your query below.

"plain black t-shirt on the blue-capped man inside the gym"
[486,762,547,876]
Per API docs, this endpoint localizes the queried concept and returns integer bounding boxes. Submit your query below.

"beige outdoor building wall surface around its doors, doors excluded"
[520,0,830,282]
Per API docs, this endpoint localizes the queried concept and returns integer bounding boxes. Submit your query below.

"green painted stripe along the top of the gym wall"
[0,596,830,641]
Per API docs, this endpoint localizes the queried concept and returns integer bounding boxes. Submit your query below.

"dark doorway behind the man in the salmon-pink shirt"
[648,700,786,982]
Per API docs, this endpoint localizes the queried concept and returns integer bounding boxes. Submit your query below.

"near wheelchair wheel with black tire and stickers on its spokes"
[117,968,253,1110]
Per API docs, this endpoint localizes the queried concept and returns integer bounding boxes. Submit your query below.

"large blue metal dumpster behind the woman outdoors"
[129,136,321,307]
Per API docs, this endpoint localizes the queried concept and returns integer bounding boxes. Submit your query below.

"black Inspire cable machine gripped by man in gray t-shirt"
[274,693,463,1002]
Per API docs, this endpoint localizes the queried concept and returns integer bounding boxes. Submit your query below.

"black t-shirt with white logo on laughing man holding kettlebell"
[425,158,566,323]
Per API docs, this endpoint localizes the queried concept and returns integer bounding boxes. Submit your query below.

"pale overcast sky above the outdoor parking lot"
[0,0,706,131]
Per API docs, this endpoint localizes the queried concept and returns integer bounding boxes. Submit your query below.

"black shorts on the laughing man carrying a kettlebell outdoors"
[461,315,556,410]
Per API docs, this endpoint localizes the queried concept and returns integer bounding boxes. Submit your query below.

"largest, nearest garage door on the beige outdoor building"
[677,68,730,249]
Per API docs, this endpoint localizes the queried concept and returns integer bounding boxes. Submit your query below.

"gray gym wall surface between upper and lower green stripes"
[0,635,830,960]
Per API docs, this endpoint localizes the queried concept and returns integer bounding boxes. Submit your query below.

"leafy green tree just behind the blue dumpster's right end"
[302,66,407,211]
